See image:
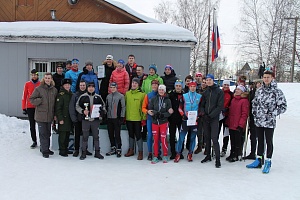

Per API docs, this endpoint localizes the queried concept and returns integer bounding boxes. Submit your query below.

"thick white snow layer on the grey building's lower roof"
[0,21,196,43]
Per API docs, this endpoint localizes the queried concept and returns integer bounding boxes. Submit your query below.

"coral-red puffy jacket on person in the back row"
[109,67,130,95]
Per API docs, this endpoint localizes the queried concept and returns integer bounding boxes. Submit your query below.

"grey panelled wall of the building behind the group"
[0,42,190,116]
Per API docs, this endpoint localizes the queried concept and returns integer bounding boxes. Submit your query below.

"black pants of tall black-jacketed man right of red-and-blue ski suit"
[203,117,220,160]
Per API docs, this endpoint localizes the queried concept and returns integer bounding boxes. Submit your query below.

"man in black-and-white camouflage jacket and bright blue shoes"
[246,71,287,173]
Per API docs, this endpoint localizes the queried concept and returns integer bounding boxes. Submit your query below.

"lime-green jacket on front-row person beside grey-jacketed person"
[125,88,146,121]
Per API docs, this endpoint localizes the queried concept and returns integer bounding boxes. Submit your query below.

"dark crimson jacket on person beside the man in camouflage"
[227,93,249,130]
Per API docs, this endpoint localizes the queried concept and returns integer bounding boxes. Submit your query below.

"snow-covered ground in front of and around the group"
[0,83,300,200]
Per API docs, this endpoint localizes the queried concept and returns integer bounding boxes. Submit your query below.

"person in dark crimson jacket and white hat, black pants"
[226,85,249,162]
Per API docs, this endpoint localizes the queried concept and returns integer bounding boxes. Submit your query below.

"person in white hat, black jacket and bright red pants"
[147,85,172,164]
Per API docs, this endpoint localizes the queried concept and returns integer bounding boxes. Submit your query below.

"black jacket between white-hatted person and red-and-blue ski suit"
[169,90,184,123]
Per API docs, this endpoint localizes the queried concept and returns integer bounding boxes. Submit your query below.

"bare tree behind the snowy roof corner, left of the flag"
[154,0,219,74]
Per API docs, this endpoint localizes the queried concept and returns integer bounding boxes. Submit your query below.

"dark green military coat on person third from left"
[55,88,72,131]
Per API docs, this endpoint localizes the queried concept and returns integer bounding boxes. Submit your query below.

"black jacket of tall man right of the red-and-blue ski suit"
[200,83,224,119]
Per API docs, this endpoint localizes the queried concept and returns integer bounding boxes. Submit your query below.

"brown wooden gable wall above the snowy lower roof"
[0,0,143,24]
